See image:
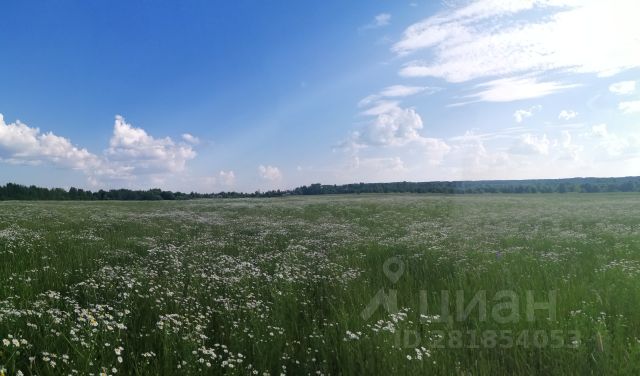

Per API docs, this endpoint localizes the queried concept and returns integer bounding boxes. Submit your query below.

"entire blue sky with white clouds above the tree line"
[0,0,640,191]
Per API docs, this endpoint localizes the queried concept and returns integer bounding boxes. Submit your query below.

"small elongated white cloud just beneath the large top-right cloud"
[456,77,578,105]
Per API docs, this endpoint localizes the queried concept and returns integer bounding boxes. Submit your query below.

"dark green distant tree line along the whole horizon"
[0,176,640,201]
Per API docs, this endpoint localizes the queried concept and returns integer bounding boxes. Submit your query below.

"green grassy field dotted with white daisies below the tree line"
[0,194,640,375]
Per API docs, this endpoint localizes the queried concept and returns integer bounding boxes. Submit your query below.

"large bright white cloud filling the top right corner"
[393,0,640,82]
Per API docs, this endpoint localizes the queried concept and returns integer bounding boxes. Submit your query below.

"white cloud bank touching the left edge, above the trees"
[0,114,101,170]
